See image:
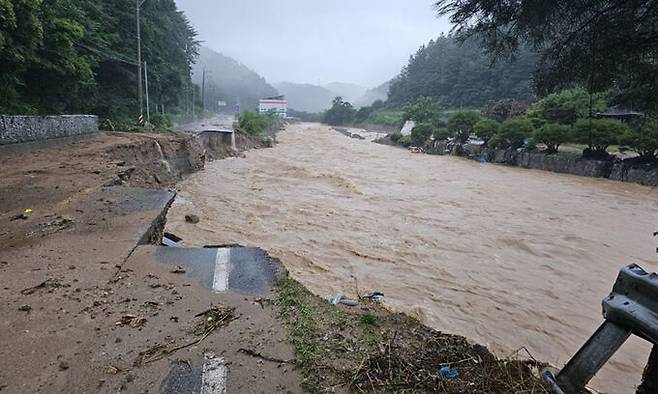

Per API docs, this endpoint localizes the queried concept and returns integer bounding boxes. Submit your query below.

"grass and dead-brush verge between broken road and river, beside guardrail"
[276,277,549,394]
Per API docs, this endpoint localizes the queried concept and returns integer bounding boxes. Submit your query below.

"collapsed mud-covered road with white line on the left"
[0,133,301,394]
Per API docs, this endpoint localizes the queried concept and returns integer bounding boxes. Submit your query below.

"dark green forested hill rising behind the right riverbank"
[388,36,536,108]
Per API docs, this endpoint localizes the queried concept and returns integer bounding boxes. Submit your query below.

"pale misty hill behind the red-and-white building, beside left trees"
[192,47,279,111]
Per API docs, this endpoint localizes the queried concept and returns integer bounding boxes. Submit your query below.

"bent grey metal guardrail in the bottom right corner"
[543,264,658,394]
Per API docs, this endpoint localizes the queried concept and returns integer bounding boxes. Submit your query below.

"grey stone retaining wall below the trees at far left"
[0,115,98,145]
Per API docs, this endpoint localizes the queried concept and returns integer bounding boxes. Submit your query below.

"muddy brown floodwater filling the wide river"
[167,124,658,393]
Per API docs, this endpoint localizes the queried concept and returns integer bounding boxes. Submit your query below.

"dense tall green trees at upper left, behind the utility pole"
[0,0,198,119]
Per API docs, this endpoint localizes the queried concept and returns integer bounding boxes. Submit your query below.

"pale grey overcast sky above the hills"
[176,0,450,87]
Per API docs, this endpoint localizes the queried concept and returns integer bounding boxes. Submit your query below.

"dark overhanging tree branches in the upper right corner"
[436,0,658,112]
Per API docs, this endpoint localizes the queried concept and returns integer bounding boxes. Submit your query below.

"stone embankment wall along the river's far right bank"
[471,150,658,187]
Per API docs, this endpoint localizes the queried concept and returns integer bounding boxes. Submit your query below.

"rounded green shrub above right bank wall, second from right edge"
[574,119,629,157]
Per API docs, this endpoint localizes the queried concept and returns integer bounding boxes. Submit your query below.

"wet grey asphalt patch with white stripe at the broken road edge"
[155,245,280,295]
